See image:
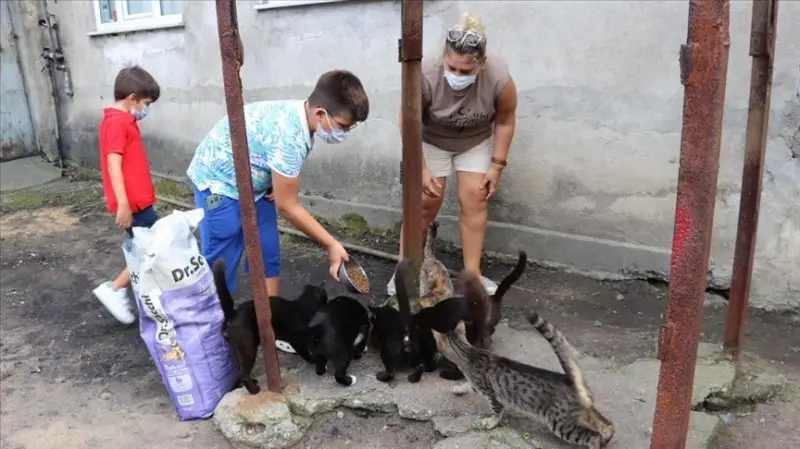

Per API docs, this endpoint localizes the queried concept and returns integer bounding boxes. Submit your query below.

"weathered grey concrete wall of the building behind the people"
[21,1,800,308]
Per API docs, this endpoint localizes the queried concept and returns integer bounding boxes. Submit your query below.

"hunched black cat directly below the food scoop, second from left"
[308,296,370,386]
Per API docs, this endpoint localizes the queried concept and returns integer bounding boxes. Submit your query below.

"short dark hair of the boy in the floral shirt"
[308,70,369,122]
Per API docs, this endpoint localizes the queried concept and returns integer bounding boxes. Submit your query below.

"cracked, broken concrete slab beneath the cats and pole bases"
[214,324,734,449]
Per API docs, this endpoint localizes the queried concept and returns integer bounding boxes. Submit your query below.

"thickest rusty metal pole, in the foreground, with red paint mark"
[650,0,730,449]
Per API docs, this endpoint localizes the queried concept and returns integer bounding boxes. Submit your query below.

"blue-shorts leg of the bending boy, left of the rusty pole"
[193,187,244,292]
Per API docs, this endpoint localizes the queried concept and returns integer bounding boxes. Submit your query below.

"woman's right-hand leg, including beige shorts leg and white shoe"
[453,139,497,295]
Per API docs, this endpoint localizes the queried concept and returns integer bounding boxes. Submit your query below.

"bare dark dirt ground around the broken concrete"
[0,181,800,449]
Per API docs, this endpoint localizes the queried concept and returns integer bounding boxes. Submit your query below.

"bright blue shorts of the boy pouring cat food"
[192,186,281,291]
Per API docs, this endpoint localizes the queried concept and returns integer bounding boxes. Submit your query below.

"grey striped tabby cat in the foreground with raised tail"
[433,272,615,449]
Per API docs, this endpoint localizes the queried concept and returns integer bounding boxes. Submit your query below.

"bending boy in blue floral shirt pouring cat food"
[186,70,369,295]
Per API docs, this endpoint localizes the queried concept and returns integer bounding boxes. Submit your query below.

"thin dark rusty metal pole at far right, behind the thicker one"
[725,0,778,361]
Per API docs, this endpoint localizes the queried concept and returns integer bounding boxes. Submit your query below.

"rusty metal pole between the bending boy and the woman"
[399,0,422,272]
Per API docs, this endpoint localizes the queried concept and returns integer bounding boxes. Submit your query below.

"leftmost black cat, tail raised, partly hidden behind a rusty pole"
[212,259,328,394]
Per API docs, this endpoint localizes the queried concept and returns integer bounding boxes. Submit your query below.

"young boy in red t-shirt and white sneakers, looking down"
[93,66,161,324]
